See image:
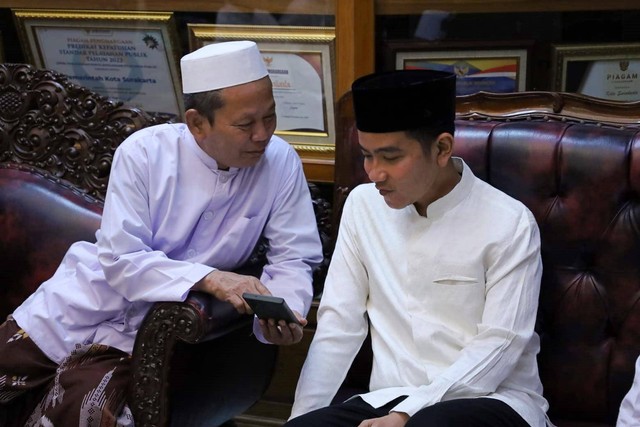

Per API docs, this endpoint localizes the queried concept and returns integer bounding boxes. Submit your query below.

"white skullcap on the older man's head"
[180,41,268,93]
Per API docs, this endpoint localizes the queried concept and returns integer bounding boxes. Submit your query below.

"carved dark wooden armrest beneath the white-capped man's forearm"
[128,291,253,427]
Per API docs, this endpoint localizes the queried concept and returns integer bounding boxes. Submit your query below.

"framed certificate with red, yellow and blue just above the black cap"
[387,41,529,96]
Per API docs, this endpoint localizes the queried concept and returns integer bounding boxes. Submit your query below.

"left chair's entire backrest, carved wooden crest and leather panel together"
[0,64,160,322]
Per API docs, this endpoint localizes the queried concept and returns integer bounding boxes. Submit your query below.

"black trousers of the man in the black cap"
[285,396,530,427]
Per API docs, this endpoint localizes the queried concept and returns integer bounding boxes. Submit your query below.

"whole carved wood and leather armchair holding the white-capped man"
[0,64,330,427]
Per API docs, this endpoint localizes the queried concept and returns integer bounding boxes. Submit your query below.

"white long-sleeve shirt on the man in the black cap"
[291,158,548,426]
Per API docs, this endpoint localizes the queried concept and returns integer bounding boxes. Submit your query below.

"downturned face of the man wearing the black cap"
[358,132,453,215]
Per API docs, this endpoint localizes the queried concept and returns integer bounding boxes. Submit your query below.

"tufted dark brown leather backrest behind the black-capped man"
[334,93,640,426]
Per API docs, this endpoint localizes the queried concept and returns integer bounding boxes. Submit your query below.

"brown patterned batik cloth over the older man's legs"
[0,319,131,427]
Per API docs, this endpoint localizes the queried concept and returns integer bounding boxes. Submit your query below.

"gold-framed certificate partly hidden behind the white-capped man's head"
[187,24,335,181]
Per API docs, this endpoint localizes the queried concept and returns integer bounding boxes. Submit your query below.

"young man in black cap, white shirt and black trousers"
[287,70,547,427]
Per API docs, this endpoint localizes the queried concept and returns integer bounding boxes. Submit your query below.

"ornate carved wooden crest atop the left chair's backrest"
[0,64,164,200]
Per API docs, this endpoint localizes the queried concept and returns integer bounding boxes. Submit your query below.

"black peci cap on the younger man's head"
[351,70,456,134]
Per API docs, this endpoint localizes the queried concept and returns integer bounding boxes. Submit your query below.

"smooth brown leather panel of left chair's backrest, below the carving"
[0,169,102,323]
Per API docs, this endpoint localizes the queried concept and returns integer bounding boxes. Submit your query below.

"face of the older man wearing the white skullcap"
[196,76,276,169]
